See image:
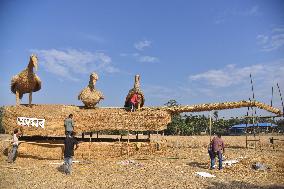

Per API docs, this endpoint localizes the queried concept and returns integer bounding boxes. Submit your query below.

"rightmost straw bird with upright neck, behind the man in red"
[124,75,145,109]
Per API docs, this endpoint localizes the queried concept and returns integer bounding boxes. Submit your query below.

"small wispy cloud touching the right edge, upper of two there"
[256,28,284,52]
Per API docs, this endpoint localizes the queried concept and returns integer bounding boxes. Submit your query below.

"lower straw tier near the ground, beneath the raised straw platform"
[14,141,156,160]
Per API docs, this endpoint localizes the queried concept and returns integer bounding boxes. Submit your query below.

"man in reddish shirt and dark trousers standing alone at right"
[208,133,225,170]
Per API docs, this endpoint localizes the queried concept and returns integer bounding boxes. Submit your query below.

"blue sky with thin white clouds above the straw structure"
[0,0,284,116]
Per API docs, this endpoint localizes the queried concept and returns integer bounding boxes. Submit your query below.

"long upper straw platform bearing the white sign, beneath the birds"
[2,105,171,136]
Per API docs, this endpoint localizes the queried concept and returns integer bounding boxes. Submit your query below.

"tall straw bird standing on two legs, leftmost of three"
[11,54,41,105]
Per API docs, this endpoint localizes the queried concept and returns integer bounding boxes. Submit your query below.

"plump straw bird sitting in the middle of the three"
[78,72,104,108]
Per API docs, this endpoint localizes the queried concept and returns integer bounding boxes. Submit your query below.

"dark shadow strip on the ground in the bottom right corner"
[207,181,284,189]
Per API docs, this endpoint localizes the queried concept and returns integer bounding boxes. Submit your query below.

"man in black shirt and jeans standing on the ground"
[64,132,78,175]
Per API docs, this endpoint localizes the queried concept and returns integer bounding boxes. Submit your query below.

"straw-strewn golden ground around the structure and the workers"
[0,136,284,189]
